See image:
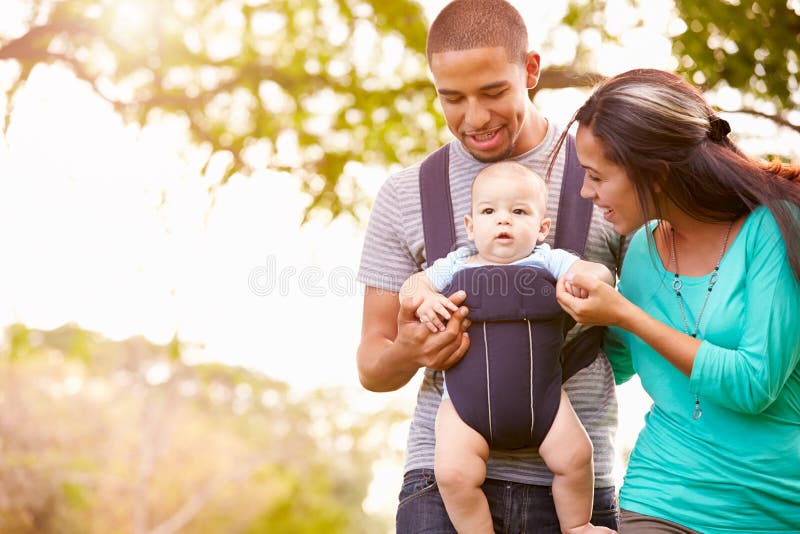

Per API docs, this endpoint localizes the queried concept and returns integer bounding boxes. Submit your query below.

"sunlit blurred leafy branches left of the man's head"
[0,0,441,223]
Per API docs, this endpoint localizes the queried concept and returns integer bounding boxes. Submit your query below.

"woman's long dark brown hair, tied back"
[554,69,800,281]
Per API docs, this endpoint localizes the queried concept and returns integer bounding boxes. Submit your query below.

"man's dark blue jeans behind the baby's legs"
[397,469,617,534]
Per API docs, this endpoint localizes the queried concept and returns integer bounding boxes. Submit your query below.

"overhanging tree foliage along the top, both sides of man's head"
[0,0,800,222]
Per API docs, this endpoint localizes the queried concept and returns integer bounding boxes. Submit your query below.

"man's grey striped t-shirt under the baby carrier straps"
[358,125,622,487]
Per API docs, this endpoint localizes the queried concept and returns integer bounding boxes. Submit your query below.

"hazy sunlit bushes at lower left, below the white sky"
[0,325,407,534]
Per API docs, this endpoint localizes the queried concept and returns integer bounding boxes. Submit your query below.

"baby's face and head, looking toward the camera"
[464,166,550,264]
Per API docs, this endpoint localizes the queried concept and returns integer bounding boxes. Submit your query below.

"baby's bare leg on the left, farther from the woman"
[434,400,494,534]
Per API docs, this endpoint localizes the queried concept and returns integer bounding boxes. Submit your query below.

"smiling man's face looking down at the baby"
[430,47,539,162]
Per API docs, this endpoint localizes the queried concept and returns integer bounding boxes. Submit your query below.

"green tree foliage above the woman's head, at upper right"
[556,0,800,132]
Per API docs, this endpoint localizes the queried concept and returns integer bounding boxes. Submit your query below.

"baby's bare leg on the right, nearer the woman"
[539,390,613,534]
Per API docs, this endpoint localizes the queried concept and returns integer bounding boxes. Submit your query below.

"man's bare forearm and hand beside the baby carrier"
[356,286,469,391]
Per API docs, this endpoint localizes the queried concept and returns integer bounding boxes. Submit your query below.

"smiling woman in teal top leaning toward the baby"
[558,70,800,534]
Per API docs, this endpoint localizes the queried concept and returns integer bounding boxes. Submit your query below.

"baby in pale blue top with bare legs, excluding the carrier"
[400,162,613,533]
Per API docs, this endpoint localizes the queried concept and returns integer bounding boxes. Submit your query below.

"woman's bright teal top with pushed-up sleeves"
[606,207,800,534]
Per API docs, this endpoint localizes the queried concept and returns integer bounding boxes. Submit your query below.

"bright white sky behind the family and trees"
[0,0,800,528]
